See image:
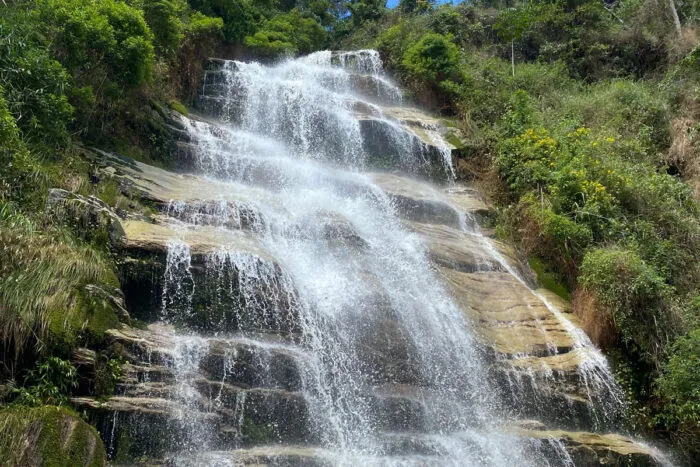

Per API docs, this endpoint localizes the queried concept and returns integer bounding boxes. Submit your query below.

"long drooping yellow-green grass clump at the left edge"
[0,201,117,358]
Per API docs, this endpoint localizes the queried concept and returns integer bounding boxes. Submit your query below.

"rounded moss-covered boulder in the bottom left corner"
[0,406,106,467]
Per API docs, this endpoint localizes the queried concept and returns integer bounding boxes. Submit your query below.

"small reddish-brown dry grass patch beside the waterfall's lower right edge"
[572,287,619,349]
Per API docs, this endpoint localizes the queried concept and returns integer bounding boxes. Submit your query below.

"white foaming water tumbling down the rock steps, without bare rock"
[148,51,636,466]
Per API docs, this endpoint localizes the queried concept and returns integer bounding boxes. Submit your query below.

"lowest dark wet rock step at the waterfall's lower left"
[71,386,318,459]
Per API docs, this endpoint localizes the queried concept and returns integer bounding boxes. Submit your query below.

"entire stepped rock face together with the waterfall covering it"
[72,51,668,466]
